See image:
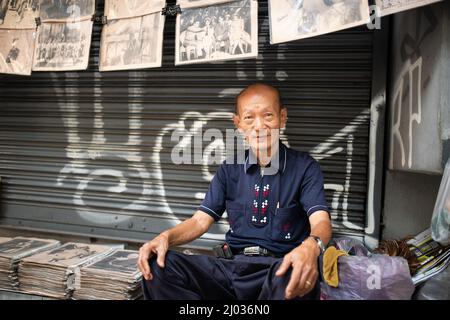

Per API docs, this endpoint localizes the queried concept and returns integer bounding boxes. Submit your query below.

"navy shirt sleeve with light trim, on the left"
[198,164,227,221]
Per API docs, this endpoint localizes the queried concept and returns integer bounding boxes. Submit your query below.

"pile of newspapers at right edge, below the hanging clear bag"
[408,229,450,286]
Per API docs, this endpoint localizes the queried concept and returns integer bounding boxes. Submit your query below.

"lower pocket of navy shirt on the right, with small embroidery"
[270,205,304,242]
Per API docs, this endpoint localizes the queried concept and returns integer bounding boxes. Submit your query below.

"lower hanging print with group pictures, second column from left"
[33,20,93,71]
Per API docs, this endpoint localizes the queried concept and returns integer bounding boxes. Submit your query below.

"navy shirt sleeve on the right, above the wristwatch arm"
[300,158,330,217]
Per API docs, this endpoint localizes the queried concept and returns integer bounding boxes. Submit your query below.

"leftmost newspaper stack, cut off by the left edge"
[0,237,60,291]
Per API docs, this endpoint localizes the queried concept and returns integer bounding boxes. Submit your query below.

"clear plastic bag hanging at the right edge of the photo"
[431,159,450,246]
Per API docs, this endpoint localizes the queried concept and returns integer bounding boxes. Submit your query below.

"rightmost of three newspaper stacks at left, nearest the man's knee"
[73,250,142,300]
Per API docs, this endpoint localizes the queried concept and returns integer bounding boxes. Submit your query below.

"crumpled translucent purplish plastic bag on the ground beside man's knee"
[321,239,415,300]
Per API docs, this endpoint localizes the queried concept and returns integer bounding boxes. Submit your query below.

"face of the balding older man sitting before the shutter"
[233,87,287,155]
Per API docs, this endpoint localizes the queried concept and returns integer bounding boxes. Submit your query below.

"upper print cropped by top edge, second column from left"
[40,0,95,22]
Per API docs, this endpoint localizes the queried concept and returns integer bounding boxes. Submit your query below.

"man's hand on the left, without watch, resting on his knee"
[137,233,169,280]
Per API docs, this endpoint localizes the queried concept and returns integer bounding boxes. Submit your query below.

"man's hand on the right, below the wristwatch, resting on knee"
[275,238,320,299]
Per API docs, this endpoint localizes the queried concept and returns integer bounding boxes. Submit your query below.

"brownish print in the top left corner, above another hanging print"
[0,0,39,29]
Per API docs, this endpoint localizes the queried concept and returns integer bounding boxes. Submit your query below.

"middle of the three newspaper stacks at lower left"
[19,242,112,299]
